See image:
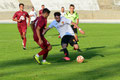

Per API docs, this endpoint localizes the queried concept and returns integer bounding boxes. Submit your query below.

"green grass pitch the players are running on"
[0,24,120,80]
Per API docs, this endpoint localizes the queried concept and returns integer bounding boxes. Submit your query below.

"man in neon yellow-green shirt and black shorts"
[65,4,79,41]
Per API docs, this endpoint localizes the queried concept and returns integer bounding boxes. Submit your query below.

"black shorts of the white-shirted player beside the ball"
[61,35,77,46]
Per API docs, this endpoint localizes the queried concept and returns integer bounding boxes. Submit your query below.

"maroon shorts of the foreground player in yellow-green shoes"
[34,36,50,49]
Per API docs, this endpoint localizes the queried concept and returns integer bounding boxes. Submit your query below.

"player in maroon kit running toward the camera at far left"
[13,3,30,50]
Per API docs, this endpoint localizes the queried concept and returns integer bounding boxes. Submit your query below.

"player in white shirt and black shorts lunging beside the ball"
[43,12,84,60]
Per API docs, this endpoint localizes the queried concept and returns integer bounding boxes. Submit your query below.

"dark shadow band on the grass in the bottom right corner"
[52,63,120,80]
